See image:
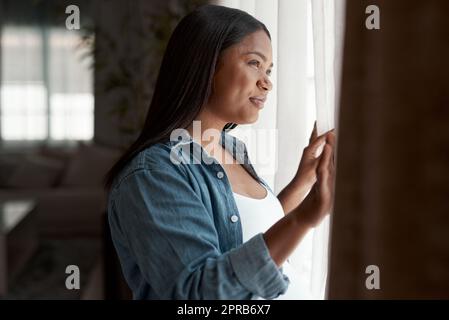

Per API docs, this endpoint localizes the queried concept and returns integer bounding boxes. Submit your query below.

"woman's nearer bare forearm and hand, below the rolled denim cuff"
[264,132,335,266]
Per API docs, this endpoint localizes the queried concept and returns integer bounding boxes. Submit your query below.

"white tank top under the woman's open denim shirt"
[233,185,306,300]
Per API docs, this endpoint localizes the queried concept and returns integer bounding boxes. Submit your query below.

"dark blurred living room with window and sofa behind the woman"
[0,0,205,299]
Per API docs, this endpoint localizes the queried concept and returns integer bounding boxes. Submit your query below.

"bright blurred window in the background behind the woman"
[0,26,94,143]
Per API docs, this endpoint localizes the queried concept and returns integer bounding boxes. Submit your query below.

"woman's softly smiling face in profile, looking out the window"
[207,30,273,124]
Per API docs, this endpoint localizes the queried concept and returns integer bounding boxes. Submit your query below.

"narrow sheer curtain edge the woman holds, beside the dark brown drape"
[311,0,345,297]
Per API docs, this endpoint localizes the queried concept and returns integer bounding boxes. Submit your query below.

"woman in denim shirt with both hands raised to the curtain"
[106,5,334,299]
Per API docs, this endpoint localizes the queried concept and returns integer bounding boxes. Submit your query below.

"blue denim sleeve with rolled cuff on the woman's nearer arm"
[109,166,289,299]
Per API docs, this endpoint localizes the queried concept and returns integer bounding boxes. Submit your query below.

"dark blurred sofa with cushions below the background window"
[0,142,120,237]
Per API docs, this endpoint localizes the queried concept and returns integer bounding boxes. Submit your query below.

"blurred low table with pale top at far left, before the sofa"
[0,199,38,297]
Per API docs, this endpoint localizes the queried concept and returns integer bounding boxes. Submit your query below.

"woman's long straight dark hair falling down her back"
[104,5,271,191]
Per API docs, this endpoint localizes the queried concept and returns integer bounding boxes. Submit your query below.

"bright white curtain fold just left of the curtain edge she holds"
[275,0,319,299]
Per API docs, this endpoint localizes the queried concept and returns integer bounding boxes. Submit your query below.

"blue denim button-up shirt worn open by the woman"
[108,132,289,300]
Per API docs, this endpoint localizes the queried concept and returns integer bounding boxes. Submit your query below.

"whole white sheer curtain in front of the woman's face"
[215,0,344,299]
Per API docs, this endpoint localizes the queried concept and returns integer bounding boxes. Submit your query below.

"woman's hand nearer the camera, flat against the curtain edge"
[298,130,335,227]
